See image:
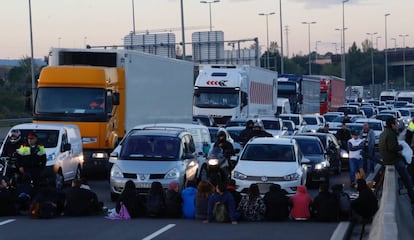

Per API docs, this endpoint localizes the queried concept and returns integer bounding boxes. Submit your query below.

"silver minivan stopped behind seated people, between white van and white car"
[110,128,199,200]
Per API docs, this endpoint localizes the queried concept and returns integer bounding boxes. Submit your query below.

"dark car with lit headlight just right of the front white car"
[282,135,329,187]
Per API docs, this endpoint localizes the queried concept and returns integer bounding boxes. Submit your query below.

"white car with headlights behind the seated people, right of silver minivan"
[231,137,310,194]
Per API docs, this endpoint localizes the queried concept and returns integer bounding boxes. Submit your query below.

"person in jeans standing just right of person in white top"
[359,123,375,173]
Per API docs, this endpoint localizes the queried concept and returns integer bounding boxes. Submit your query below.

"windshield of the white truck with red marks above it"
[194,88,239,108]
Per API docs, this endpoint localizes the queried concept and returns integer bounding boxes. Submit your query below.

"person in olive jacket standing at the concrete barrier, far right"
[379,118,414,204]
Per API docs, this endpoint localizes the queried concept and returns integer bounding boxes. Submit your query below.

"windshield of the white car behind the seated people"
[240,144,295,162]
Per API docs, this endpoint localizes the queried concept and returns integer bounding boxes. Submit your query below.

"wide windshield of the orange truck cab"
[35,87,106,114]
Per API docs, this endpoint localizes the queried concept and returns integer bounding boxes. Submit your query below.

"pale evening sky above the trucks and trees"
[0,0,414,59]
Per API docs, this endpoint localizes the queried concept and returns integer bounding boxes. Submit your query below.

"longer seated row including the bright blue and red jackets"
[111,179,378,224]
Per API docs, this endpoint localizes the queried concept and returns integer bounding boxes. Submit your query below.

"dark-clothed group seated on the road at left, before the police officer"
[0,176,103,218]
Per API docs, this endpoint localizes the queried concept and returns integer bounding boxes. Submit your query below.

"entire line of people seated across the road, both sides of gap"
[0,172,378,224]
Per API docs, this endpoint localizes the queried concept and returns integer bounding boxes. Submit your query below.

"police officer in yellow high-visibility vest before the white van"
[17,132,46,187]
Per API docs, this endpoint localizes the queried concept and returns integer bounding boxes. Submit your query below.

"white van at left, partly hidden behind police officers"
[0,123,83,184]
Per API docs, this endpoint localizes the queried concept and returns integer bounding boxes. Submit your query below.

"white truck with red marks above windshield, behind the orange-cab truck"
[193,65,277,124]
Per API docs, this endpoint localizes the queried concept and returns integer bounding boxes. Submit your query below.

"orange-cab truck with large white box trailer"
[33,48,194,171]
